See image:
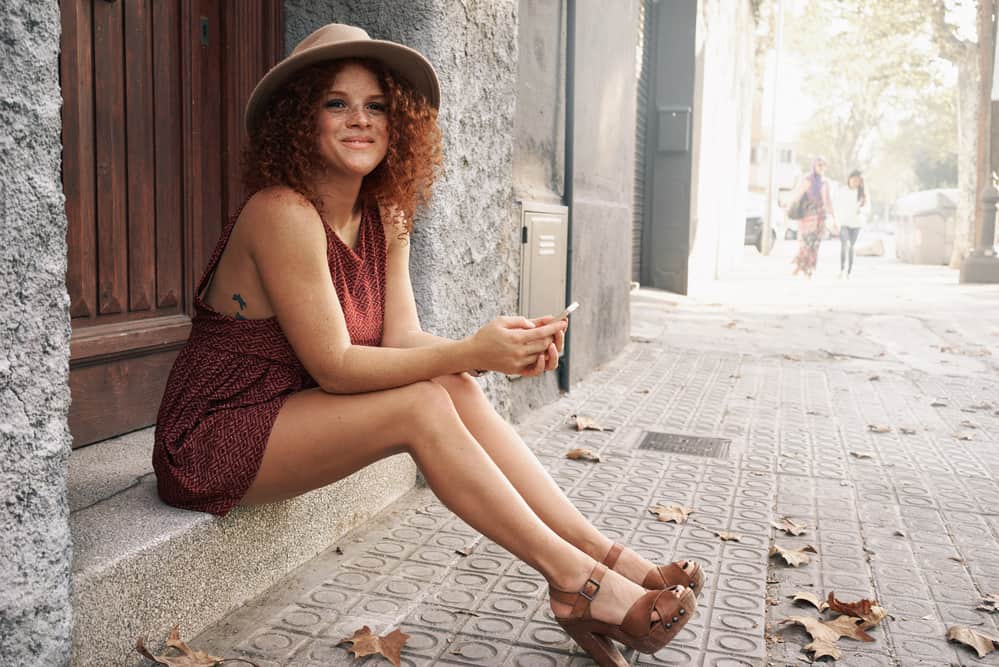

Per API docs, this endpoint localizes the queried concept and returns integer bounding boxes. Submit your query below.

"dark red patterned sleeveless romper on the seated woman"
[153,208,385,514]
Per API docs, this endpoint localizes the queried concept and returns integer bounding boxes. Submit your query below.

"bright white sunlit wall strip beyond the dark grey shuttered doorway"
[687,0,756,294]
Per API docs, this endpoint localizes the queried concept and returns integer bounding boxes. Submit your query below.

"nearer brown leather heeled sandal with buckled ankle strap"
[548,563,697,667]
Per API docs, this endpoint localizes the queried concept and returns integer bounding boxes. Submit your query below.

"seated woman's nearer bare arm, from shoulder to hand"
[244,197,561,394]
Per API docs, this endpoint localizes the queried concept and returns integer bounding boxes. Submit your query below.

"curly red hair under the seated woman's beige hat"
[243,59,441,233]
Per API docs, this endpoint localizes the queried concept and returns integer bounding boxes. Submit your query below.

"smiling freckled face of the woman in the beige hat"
[316,63,388,178]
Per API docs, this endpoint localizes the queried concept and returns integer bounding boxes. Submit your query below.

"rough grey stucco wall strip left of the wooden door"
[0,0,71,666]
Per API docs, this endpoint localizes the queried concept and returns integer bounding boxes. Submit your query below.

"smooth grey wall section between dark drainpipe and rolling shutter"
[569,0,638,383]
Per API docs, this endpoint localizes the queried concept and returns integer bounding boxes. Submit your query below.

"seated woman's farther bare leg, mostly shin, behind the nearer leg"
[434,374,655,582]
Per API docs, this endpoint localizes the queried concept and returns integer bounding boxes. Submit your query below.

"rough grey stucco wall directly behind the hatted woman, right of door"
[285,0,534,413]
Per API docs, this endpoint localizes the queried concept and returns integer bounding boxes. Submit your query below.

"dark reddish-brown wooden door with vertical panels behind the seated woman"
[60,0,283,447]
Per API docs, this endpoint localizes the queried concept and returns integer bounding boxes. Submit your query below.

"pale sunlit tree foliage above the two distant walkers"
[785,0,973,197]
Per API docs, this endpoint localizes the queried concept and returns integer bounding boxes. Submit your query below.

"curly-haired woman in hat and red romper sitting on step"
[153,24,703,665]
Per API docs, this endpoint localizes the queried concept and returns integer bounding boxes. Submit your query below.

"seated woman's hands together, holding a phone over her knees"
[466,317,568,375]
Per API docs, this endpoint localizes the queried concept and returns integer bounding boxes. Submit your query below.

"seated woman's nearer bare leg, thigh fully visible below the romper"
[243,382,660,623]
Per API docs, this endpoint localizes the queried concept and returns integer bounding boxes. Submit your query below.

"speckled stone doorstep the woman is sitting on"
[68,429,416,667]
